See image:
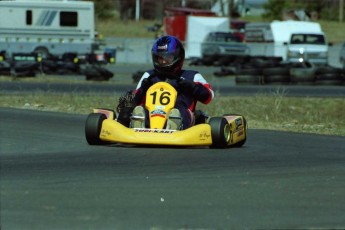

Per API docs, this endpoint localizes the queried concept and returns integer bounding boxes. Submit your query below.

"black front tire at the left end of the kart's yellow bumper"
[85,113,107,145]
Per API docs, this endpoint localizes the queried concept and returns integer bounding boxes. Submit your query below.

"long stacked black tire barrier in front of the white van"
[194,56,345,86]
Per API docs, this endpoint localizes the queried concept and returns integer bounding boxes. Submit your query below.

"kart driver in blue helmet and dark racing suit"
[130,36,214,130]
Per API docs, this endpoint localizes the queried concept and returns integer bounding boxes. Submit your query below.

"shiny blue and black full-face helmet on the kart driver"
[151,36,185,74]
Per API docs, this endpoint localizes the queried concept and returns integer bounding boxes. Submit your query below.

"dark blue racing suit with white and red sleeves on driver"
[134,70,214,129]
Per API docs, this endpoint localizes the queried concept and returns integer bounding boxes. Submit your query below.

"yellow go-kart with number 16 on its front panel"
[85,82,247,148]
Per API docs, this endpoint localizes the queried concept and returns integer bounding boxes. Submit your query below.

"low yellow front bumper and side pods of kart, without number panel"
[97,113,247,146]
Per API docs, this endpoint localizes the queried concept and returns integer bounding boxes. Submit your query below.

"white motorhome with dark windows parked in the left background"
[0,0,99,58]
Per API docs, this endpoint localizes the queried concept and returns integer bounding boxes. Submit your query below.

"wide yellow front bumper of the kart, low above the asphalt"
[100,119,212,146]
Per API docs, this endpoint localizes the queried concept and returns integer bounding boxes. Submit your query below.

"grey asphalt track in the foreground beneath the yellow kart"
[0,108,345,230]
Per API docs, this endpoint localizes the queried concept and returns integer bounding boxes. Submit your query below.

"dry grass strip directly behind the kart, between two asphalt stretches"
[0,88,345,136]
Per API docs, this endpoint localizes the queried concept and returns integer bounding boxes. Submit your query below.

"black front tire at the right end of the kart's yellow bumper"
[209,117,230,148]
